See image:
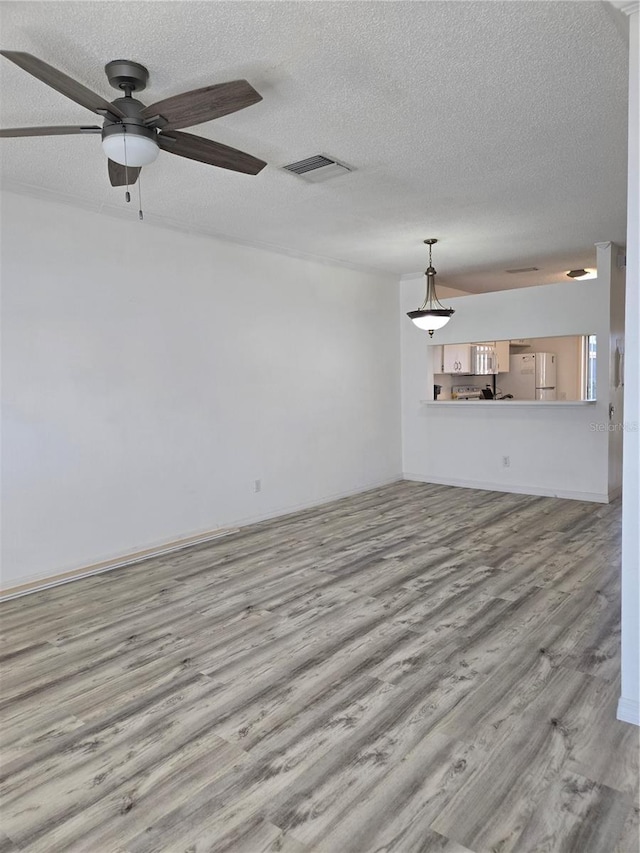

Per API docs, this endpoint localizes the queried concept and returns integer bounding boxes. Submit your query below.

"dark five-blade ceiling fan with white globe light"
[0,50,267,187]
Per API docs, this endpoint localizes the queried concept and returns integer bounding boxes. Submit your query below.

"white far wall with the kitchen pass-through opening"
[400,266,609,502]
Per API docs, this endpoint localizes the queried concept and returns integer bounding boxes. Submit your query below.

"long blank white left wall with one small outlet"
[2,193,401,586]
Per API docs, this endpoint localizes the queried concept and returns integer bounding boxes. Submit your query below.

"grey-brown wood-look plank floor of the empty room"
[0,482,639,853]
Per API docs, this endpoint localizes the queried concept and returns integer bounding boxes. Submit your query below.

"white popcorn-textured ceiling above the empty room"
[0,0,628,292]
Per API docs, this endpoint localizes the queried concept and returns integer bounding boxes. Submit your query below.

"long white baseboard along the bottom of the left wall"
[0,474,403,602]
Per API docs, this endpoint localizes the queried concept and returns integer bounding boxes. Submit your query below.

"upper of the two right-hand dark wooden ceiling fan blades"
[142,80,262,130]
